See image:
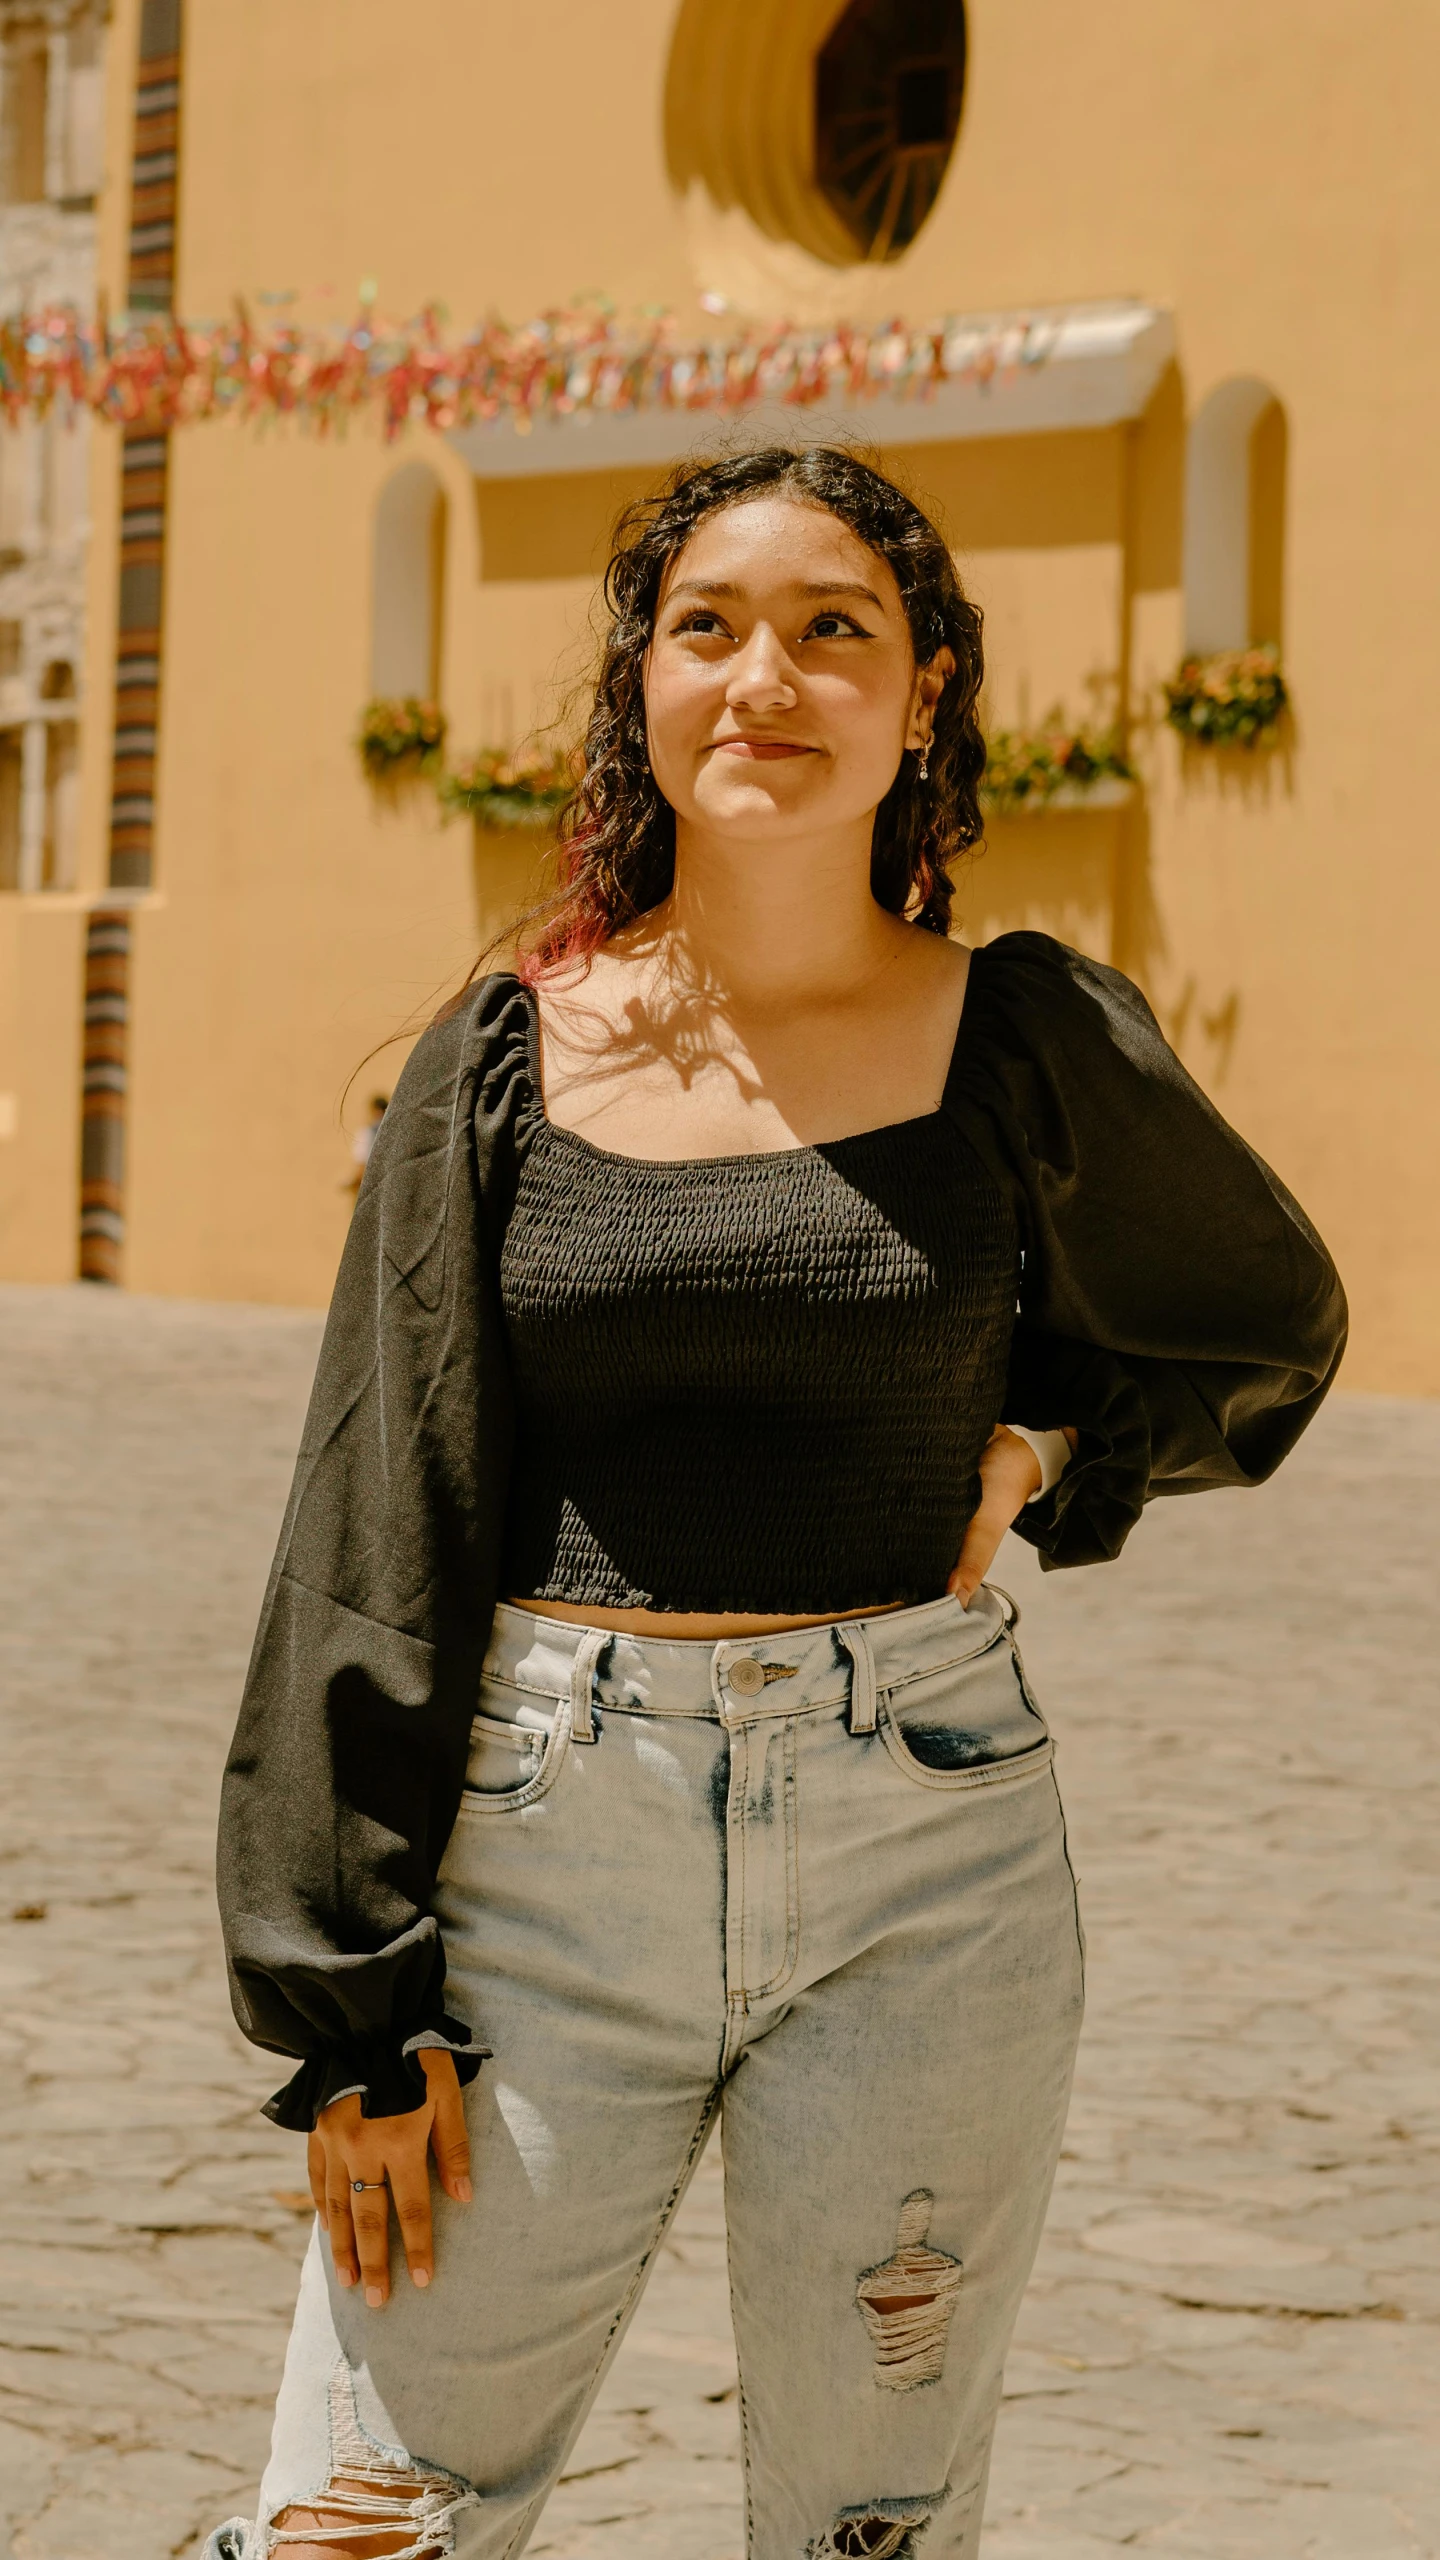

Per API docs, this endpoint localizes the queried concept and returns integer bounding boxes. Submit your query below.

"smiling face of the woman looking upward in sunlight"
[646,494,953,840]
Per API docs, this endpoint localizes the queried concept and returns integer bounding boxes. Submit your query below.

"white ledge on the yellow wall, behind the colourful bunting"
[448,302,1174,479]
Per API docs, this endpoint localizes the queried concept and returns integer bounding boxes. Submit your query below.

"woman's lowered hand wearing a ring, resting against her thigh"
[307,2048,471,2312]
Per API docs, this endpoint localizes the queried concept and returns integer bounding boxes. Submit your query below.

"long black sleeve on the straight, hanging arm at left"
[218,978,538,2130]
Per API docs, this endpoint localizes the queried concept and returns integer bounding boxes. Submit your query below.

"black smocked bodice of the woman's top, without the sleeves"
[500,1018,1020,1615]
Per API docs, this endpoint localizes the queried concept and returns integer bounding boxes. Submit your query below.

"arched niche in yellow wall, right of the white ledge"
[1184,374,1286,658]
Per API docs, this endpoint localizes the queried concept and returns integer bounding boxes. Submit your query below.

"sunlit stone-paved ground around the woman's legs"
[0,1288,1440,2560]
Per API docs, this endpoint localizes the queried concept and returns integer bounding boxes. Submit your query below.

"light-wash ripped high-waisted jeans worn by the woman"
[208,1590,1081,2560]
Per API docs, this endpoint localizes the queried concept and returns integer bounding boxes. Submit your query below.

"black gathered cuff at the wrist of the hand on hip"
[1002,1334,1150,1572]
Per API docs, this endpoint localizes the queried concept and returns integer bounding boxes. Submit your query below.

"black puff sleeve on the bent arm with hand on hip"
[945,934,1345,1567]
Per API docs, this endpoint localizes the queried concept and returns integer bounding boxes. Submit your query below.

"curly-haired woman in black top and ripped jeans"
[210,451,1343,2560]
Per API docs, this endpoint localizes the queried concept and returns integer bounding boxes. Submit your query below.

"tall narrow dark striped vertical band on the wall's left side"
[79,0,182,1283]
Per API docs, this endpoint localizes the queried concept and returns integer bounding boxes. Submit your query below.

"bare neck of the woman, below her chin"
[646,817,897,1011]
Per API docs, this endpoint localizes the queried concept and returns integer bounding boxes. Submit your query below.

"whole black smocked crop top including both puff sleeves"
[220,934,1345,2125]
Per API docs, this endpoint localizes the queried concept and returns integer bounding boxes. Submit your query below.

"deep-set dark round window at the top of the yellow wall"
[666,0,966,266]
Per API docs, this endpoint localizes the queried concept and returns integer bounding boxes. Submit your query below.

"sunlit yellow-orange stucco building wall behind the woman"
[0,0,1440,1393]
